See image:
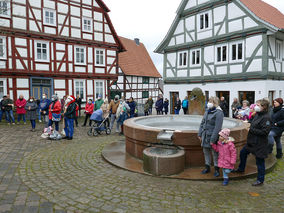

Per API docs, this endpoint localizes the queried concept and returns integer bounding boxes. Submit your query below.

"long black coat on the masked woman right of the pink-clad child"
[245,112,271,159]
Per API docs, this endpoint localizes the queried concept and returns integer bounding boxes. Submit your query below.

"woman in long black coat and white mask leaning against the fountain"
[235,99,271,186]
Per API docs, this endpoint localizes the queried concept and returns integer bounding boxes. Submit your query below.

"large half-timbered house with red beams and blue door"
[0,0,124,101]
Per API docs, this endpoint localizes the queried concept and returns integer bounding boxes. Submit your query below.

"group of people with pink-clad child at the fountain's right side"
[198,97,284,186]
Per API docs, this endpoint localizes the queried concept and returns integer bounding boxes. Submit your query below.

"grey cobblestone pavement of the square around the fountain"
[0,120,284,213]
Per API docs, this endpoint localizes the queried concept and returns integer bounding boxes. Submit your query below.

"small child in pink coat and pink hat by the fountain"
[211,129,237,186]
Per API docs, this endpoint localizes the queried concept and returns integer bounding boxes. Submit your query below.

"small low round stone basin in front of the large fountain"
[143,147,185,176]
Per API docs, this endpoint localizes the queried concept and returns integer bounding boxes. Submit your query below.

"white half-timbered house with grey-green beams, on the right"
[155,0,284,115]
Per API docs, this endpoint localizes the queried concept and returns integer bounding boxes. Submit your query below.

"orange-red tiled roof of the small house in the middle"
[118,37,162,78]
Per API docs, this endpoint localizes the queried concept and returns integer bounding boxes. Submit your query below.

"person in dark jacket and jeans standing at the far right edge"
[268,98,284,159]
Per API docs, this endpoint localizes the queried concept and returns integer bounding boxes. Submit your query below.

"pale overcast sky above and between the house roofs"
[104,0,284,73]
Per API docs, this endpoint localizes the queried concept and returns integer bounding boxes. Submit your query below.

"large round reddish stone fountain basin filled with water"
[123,115,249,167]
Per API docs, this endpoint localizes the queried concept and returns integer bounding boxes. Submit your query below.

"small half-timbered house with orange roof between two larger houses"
[111,37,162,104]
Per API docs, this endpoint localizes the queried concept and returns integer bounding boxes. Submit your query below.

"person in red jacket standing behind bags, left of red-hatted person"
[48,95,61,131]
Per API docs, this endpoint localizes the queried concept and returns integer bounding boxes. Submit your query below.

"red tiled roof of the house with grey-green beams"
[240,0,284,29]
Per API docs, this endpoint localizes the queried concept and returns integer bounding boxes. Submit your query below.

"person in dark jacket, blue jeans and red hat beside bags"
[63,95,77,140]
